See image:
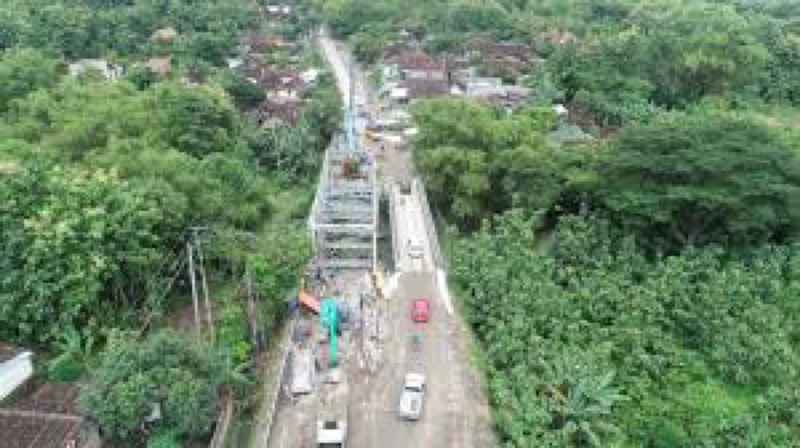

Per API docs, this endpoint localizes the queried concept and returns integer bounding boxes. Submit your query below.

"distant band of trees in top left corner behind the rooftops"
[0,0,258,65]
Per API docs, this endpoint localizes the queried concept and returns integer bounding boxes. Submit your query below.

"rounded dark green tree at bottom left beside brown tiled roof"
[79,331,226,445]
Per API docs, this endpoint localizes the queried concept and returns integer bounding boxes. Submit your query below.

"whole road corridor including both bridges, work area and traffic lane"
[262,28,490,448]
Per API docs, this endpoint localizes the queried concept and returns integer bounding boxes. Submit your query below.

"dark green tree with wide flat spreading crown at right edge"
[597,112,800,248]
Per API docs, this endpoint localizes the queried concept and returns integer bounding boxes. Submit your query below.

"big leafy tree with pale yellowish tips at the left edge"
[0,155,168,344]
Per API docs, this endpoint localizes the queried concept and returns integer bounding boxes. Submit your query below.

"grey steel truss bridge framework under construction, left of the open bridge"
[309,103,379,271]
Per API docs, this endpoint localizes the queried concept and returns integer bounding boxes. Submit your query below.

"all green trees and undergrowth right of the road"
[310,0,800,448]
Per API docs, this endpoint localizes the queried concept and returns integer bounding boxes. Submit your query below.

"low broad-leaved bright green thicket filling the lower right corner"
[451,213,800,448]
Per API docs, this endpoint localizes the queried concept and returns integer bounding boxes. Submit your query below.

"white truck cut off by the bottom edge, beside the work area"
[317,369,348,448]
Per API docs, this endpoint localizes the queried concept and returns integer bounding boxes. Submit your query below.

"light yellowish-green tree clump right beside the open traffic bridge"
[413,99,580,228]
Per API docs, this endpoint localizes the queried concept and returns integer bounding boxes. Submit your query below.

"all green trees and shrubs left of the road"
[0,0,332,447]
